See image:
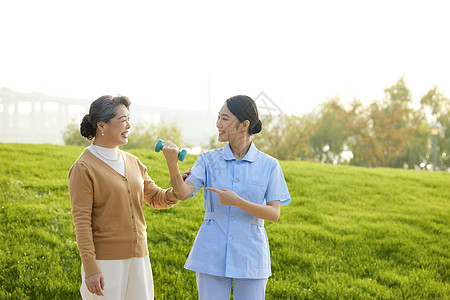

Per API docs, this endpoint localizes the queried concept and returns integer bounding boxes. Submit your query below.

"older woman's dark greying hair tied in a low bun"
[80,95,131,140]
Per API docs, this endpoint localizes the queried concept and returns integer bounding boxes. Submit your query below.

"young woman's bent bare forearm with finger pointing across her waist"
[205,187,280,222]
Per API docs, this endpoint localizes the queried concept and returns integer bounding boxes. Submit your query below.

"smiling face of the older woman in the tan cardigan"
[100,105,131,147]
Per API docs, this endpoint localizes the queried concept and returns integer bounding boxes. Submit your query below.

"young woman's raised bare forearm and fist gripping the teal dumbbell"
[163,141,195,200]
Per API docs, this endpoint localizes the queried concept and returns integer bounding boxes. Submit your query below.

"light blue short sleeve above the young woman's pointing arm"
[265,161,291,206]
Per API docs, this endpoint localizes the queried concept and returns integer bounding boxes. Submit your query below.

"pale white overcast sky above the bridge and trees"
[0,0,450,117]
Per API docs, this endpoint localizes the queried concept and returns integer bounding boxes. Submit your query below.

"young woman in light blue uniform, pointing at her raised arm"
[163,96,291,300]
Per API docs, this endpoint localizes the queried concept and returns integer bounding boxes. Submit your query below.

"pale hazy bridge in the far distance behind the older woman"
[0,88,215,146]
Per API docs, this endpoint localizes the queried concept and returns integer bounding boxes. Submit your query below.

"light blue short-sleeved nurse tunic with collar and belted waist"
[184,142,291,279]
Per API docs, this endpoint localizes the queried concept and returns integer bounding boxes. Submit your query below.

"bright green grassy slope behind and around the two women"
[0,144,450,299]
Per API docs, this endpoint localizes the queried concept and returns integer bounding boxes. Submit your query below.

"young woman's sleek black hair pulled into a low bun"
[225,95,262,135]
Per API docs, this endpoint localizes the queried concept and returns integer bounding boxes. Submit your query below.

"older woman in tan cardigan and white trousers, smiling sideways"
[69,96,178,299]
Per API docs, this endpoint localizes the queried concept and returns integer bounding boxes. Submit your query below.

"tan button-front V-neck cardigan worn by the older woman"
[69,149,178,277]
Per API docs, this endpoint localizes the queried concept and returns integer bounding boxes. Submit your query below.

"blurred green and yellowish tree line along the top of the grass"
[63,77,450,170]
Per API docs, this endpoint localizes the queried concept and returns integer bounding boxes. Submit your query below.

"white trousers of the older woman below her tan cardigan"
[80,256,154,300]
